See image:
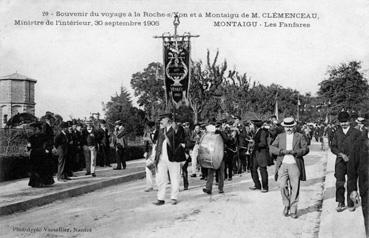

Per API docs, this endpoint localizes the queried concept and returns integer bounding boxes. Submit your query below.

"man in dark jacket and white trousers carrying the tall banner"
[154,113,186,206]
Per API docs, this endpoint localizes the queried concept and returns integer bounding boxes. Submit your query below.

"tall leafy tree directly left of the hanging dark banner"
[131,62,165,120]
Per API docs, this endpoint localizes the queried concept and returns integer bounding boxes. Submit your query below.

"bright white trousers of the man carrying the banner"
[156,156,181,200]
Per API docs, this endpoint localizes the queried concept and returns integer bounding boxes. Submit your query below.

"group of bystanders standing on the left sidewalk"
[27,115,127,187]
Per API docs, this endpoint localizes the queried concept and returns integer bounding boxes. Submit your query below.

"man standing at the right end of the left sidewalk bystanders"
[114,120,128,170]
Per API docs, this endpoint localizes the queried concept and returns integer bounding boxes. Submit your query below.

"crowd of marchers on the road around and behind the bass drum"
[145,111,369,234]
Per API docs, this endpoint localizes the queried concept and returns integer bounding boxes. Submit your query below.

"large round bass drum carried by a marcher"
[198,133,224,169]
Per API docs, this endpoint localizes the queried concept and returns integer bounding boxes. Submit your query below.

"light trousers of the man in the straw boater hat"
[278,163,300,213]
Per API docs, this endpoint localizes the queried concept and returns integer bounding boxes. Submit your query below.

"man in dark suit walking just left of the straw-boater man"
[250,120,269,193]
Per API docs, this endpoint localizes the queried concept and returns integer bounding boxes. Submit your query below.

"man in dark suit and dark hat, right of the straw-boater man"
[331,111,361,212]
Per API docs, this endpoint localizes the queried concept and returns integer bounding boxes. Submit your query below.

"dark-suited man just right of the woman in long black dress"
[54,122,70,182]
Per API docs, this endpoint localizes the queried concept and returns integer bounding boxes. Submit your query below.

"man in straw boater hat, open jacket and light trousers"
[270,117,309,219]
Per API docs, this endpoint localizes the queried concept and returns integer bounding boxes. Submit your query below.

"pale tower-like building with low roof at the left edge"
[0,73,37,128]
